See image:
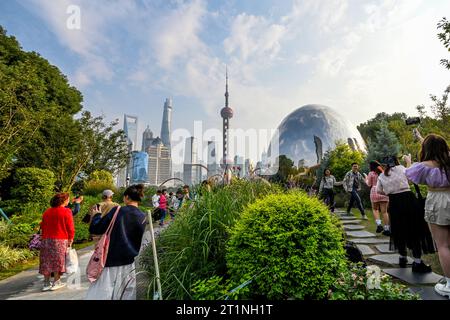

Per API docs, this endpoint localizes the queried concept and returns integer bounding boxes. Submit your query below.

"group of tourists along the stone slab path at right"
[319,130,450,298]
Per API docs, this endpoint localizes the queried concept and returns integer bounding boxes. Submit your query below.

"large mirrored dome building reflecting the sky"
[278,104,365,166]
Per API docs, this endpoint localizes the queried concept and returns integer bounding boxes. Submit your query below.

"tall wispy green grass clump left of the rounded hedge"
[141,180,281,299]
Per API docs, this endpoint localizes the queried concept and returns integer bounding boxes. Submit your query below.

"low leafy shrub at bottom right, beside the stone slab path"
[329,264,419,300]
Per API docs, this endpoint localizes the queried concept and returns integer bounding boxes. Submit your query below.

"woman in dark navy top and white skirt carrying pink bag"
[86,185,146,300]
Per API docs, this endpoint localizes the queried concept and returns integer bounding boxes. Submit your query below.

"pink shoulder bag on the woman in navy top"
[86,206,120,283]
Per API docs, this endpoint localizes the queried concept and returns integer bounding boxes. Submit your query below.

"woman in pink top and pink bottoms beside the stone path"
[366,161,391,236]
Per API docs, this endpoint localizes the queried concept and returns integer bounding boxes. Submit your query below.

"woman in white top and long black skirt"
[377,156,435,273]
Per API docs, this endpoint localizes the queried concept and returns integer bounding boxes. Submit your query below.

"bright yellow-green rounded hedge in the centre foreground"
[226,192,346,299]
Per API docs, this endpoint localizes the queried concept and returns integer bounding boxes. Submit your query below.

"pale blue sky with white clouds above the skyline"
[0,0,450,165]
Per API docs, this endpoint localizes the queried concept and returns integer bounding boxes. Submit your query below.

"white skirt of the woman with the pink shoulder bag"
[85,263,136,300]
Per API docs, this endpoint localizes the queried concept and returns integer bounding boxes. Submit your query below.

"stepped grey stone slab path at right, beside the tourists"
[336,210,447,300]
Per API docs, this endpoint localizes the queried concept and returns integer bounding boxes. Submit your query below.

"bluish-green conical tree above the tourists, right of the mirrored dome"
[367,125,401,161]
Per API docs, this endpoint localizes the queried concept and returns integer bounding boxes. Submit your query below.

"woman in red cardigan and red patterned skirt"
[39,193,75,291]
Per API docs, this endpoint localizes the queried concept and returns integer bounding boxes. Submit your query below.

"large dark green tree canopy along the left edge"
[0,26,129,191]
